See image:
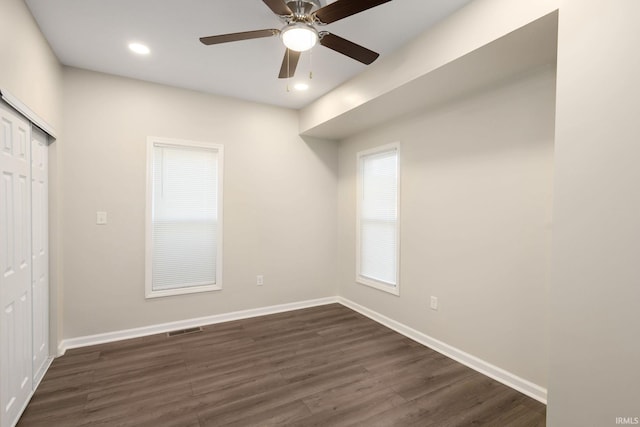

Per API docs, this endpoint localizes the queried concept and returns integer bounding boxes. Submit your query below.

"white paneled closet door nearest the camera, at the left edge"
[0,105,33,426]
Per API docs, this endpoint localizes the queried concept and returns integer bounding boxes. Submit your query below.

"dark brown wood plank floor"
[18,304,545,427]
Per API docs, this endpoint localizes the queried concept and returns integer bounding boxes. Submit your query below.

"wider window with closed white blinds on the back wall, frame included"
[145,137,223,298]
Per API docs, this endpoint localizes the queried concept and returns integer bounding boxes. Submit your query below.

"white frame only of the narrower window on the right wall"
[356,142,401,296]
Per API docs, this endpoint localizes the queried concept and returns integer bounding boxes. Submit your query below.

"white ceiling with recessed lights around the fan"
[25,0,471,109]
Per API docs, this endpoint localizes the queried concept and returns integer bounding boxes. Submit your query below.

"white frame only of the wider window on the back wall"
[145,136,224,299]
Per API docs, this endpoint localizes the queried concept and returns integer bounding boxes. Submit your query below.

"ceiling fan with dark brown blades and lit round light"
[200,0,391,79]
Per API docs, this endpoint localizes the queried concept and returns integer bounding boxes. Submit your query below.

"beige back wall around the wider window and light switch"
[61,68,337,338]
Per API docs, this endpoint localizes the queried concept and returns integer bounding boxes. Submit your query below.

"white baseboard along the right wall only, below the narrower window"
[337,297,547,405]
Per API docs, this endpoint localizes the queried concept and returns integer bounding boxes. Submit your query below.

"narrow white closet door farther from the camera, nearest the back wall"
[31,127,49,384]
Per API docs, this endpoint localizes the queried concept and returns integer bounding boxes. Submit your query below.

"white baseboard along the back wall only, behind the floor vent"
[58,297,338,356]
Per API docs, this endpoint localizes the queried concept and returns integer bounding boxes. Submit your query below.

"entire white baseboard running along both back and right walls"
[53,297,547,404]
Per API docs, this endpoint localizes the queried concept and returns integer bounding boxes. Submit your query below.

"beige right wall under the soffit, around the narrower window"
[338,67,555,387]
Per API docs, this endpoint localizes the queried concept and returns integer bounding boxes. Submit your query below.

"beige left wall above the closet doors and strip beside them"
[0,0,62,348]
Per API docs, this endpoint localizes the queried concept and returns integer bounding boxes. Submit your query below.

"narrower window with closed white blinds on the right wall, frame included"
[356,143,400,295]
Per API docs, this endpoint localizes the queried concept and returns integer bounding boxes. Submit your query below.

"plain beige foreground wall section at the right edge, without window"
[548,0,640,427]
